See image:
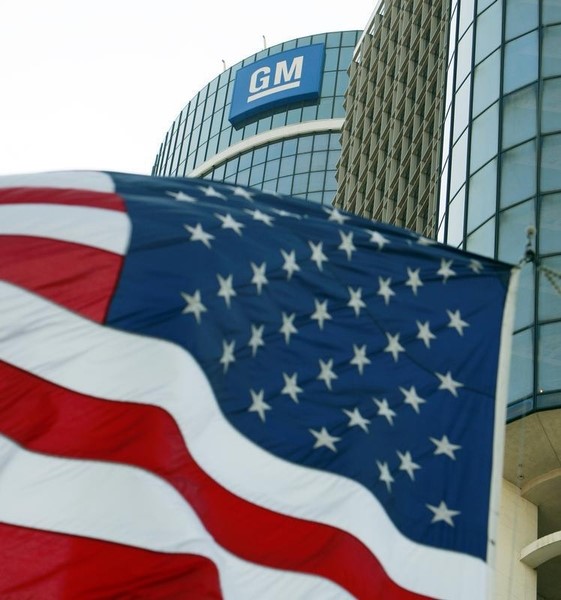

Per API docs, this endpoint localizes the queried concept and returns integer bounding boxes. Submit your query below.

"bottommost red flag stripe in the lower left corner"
[0,523,222,600]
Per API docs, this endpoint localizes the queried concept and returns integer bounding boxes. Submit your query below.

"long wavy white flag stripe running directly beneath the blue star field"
[0,284,486,600]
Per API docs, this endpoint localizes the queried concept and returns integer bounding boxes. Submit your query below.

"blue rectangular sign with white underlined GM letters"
[229,44,325,125]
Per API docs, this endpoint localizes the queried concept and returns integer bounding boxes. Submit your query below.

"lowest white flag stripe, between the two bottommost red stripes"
[0,435,350,600]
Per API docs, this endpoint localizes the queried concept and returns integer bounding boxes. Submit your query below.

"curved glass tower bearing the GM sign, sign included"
[152,31,361,204]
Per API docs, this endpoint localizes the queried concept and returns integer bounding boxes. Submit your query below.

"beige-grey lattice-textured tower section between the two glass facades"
[335,0,449,236]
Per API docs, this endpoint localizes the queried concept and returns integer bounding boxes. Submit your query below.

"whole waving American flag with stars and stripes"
[0,171,515,600]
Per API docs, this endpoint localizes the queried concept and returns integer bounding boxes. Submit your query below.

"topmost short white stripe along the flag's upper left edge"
[0,171,115,193]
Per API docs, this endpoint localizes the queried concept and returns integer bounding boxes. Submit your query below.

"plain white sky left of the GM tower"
[0,0,375,175]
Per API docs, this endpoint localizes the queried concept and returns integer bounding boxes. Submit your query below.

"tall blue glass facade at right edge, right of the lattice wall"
[438,0,561,419]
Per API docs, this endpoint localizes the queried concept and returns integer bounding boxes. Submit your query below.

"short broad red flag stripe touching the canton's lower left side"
[0,236,123,322]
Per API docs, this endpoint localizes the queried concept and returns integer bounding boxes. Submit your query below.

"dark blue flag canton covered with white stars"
[107,175,510,558]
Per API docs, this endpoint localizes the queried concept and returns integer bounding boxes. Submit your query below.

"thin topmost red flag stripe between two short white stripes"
[0,187,126,212]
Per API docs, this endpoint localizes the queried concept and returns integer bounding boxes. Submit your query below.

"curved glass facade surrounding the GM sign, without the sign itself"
[152,31,361,203]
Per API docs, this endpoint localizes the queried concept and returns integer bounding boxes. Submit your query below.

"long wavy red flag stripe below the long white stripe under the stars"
[0,363,428,600]
